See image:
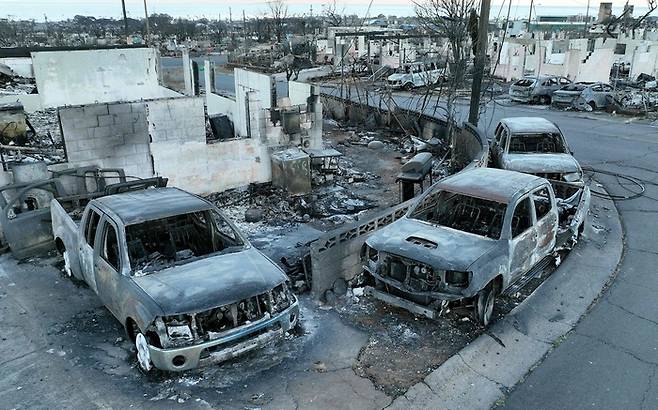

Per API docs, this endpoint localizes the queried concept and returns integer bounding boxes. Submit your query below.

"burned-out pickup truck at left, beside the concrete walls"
[51,187,299,371]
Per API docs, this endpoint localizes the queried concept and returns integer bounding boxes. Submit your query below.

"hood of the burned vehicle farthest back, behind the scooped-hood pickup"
[503,154,580,174]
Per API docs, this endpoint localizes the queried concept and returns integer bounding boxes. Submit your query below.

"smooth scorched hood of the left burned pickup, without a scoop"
[133,248,286,315]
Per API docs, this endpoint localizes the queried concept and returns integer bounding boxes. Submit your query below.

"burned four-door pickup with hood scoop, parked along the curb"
[362,168,580,326]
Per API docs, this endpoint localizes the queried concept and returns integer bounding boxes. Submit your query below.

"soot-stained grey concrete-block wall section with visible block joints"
[58,102,153,178]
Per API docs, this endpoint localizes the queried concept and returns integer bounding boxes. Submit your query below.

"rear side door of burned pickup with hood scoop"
[531,185,558,258]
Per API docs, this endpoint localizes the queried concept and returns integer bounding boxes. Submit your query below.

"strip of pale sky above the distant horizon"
[0,0,658,21]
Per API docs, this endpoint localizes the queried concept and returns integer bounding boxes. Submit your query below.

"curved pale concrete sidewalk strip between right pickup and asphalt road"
[387,188,623,410]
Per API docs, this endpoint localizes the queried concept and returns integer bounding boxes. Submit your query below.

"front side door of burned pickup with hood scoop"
[509,195,537,281]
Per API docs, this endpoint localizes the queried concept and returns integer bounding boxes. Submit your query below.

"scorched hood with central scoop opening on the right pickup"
[366,217,498,271]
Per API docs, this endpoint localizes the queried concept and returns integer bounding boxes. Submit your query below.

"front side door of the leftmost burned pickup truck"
[94,216,124,318]
